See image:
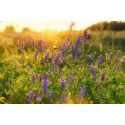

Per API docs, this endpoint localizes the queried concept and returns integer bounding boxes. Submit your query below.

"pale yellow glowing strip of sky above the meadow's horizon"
[0,21,94,31]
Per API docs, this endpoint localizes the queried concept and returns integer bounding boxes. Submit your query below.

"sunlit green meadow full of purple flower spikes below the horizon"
[0,30,125,104]
